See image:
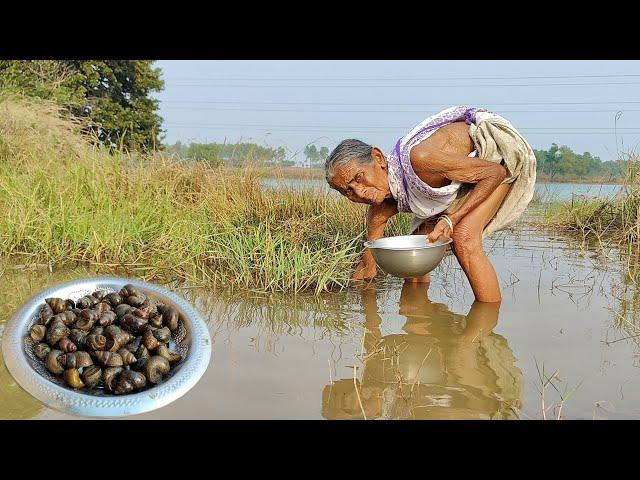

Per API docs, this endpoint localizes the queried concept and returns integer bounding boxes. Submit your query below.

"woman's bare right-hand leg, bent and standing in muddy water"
[452,184,511,302]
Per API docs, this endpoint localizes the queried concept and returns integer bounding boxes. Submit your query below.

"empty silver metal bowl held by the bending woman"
[364,235,453,278]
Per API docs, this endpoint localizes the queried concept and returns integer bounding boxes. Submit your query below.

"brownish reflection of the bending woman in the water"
[322,284,524,419]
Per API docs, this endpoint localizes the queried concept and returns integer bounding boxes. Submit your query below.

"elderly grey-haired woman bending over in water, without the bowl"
[325,107,536,302]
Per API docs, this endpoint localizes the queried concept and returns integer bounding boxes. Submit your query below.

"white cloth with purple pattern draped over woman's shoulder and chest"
[387,106,486,214]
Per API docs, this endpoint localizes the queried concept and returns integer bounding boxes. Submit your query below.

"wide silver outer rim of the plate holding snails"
[2,276,211,417]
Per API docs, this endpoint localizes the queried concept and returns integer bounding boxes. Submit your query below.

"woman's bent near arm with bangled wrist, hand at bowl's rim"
[411,144,507,241]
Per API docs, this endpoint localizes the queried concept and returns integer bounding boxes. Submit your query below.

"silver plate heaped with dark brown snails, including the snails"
[2,277,211,417]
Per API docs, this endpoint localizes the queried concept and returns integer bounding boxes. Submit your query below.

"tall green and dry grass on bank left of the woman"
[0,98,404,292]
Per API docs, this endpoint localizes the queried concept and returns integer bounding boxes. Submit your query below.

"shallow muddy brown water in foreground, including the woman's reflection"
[0,227,640,419]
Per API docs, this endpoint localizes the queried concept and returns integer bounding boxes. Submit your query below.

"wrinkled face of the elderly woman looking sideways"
[332,148,392,205]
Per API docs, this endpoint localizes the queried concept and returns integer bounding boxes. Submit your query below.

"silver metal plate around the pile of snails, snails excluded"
[2,277,211,417]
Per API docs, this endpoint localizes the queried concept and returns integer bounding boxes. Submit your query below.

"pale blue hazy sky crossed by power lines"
[156,60,640,160]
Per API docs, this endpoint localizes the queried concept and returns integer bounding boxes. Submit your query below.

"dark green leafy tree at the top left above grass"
[0,60,164,149]
